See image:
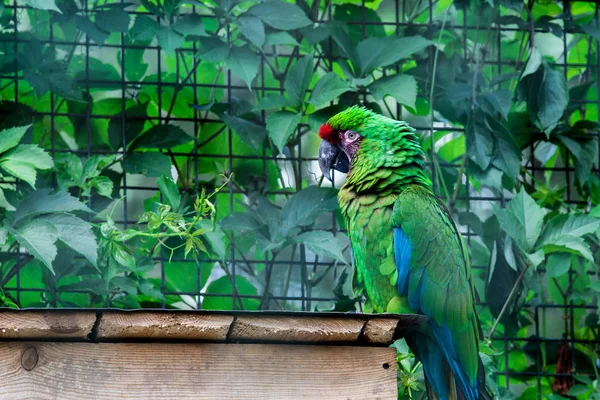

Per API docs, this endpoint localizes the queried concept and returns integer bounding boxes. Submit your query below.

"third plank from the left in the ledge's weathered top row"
[229,315,364,343]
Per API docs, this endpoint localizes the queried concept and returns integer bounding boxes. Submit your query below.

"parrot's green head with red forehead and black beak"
[319,106,423,180]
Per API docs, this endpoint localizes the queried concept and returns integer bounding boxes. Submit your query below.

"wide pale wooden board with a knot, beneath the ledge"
[0,342,397,400]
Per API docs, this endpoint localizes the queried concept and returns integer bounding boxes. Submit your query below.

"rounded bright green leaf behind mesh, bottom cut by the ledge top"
[202,275,260,310]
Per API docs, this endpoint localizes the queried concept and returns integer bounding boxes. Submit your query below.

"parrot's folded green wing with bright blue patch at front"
[394,185,479,398]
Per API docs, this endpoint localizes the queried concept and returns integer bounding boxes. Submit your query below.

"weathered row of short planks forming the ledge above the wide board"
[0,309,427,346]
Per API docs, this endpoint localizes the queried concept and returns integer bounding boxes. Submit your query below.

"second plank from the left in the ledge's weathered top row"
[96,311,233,341]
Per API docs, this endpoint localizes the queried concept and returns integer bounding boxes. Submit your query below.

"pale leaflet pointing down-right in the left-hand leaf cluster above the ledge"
[40,214,98,266]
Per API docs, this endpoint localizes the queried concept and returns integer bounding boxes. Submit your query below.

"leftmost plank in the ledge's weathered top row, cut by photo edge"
[0,311,96,339]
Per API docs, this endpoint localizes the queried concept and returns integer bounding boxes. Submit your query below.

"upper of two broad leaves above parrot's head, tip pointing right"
[355,36,433,76]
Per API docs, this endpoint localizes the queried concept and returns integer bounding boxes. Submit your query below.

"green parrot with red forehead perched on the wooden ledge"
[318,106,491,400]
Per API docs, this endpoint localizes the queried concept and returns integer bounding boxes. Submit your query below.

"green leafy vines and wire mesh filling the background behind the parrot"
[0,0,600,399]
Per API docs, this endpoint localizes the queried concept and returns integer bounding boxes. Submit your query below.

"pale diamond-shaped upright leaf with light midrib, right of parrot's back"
[494,189,544,252]
